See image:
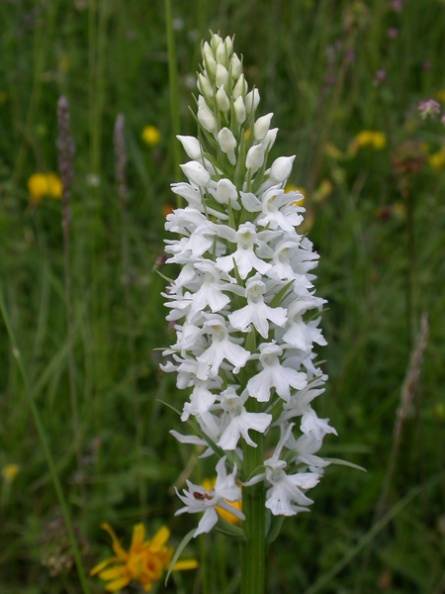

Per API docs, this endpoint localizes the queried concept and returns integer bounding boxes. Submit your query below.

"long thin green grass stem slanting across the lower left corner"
[0,292,90,594]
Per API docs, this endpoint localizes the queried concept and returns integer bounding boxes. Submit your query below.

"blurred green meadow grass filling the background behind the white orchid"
[0,0,445,594]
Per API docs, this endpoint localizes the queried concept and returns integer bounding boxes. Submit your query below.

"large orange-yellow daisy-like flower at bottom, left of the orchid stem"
[90,522,198,592]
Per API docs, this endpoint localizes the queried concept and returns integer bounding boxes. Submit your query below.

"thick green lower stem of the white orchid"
[241,418,266,594]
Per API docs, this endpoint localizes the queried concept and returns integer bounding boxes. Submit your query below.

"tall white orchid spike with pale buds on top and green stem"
[163,35,335,594]
